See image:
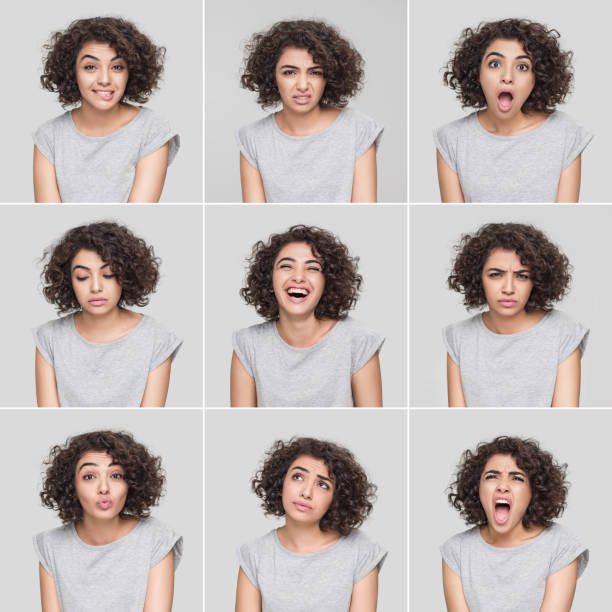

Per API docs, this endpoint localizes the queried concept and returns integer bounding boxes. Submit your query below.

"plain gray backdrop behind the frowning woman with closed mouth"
[410,204,612,406]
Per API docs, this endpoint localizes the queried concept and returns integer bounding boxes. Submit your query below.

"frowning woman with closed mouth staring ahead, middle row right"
[443,223,589,407]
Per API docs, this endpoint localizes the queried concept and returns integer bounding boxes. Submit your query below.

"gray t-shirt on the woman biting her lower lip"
[33,108,180,202]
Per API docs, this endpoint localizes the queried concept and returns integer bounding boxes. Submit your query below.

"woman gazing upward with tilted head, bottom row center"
[236,438,387,612]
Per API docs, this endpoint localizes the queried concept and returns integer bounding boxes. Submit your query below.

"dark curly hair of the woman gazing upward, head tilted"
[251,437,376,536]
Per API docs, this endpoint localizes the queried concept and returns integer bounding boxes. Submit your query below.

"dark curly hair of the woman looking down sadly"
[41,221,160,313]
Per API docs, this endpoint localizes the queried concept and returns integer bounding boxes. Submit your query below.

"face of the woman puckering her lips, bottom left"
[74,451,128,519]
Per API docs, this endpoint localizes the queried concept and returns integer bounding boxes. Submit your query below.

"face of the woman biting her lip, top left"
[75,41,128,111]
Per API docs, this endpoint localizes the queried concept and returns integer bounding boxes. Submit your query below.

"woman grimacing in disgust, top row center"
[237,20,383,202]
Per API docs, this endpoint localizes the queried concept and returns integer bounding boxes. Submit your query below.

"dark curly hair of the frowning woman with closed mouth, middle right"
[448,223,572,311]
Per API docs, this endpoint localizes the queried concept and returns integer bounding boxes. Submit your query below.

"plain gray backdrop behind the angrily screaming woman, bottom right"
[412,409,612,612]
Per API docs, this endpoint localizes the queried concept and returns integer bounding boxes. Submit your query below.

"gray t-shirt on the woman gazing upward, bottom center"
[238,529,387,612]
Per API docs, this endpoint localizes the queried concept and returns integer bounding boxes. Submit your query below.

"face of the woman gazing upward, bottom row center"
[283,455,335,523]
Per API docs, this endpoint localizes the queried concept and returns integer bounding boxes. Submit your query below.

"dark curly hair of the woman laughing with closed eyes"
[240,225,363,321]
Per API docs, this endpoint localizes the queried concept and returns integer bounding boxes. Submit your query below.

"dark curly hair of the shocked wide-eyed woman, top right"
[443,19,573,113]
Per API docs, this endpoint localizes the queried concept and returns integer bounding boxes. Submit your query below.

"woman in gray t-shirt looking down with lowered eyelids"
[33,222,182,406]
